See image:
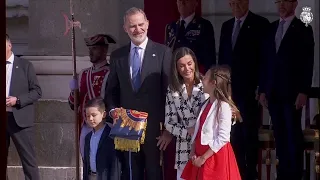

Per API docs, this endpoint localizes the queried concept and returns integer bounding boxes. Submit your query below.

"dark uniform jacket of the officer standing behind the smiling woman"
[165,15,216,73]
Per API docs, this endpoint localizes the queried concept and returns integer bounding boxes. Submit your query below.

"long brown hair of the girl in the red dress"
[209,65,241,121]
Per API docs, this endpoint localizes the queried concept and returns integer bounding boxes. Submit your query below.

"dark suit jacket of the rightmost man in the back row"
[260,17,315,100]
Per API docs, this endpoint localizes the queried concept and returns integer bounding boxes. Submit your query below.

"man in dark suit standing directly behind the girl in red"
[218,0,269,180]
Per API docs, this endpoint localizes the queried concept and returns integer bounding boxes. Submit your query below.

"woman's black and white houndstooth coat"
[165,82,209,169]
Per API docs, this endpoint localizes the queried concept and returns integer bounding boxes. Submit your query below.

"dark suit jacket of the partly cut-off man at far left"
[9,56,42,128]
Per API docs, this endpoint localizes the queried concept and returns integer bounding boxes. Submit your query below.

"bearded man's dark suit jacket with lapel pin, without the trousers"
[105,39,172,141]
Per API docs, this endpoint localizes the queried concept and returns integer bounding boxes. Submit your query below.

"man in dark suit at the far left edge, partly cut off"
[6,35,42,180]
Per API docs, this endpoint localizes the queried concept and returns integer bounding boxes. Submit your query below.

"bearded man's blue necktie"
[130,47,141,91]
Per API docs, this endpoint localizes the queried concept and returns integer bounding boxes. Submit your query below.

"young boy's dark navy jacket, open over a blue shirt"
[83,124,121,180]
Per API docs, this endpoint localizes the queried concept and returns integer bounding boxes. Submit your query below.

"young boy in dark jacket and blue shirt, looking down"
[83,98,121,180]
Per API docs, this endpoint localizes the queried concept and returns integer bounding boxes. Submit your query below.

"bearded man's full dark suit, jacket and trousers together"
[105,39,172,180]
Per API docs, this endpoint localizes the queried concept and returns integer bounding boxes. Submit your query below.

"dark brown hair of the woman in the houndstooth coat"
[169,47,201,91]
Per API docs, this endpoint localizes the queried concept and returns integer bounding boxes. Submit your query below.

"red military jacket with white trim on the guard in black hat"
[68,63,109,125]
